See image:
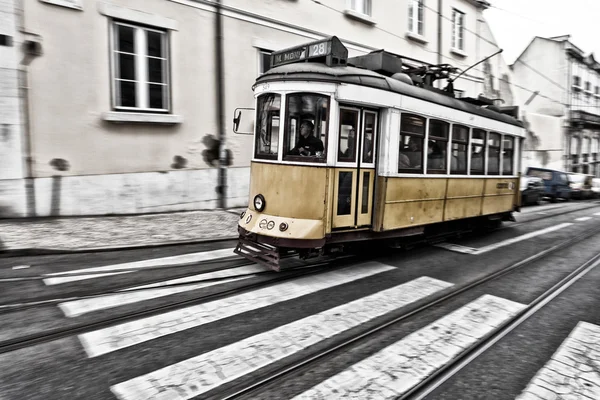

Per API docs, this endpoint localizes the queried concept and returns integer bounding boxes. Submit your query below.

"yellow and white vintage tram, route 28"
[235,37,525,270]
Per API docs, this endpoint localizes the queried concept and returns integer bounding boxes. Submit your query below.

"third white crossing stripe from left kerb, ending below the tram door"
[79,262,395,357]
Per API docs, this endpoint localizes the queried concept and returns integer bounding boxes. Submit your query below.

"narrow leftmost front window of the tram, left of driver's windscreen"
[255,93,281,160]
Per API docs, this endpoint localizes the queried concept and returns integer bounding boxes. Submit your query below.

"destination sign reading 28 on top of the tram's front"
[271,36,348,67]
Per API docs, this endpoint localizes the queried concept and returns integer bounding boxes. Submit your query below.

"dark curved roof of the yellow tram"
[256,62,523,127]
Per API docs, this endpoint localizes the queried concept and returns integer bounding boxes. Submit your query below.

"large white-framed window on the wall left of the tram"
[111,21,170,112]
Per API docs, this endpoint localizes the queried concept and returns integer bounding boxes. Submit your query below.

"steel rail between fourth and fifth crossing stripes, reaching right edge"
[217,223,600,400]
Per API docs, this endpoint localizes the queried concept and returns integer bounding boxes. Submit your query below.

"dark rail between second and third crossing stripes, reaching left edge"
[0,256,355,354]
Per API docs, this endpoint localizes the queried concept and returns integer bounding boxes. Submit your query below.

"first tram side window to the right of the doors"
[398,114,425,173]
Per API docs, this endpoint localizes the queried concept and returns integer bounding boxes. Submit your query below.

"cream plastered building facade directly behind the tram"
[0,0,512,217]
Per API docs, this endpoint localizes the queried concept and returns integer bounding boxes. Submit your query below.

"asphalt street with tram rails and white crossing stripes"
[0,201,600,400]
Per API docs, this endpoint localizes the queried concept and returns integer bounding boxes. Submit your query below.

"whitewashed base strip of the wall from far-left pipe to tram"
[27,168,250,217]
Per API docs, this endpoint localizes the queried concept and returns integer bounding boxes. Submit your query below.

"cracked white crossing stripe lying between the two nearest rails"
[294,295,525,400]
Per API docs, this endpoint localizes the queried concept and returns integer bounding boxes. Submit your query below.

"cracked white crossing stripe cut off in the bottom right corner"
[516,322,600,400]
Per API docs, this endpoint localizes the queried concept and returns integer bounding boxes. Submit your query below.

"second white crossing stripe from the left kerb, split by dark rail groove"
[58,265,265,317]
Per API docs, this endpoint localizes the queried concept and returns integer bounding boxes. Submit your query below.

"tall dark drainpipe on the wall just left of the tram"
[215,0,227,209]
